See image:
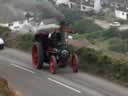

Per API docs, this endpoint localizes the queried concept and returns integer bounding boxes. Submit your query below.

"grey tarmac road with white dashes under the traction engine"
[0,48,128,96]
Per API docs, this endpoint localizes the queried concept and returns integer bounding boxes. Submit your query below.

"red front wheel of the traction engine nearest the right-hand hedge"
[71,54,78,73]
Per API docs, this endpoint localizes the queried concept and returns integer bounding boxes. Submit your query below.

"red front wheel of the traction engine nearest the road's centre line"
[49,56,57,74]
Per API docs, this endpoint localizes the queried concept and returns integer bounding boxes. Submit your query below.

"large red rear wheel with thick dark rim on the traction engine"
[32,42,44,69]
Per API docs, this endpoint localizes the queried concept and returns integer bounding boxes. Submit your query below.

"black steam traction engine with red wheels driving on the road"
[32,23,78,74]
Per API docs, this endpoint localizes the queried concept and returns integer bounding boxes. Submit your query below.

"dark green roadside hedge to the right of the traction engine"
[76,48,128,86]
